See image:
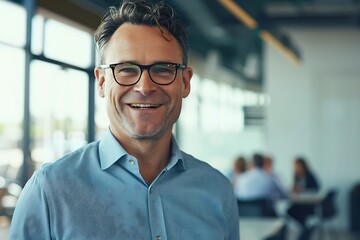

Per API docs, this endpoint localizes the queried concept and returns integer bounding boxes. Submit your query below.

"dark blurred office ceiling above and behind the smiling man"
[12,0,360,86]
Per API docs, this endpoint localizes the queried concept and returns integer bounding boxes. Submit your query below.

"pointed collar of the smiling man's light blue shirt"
[99,129,186,171]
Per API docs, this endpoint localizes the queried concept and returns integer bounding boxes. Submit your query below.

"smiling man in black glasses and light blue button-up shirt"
[10,1,239,240]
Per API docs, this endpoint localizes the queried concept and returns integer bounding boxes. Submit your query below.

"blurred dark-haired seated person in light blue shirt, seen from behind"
[234,154,288,200]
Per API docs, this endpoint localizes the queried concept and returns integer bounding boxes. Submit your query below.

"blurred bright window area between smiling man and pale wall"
[178,74,267,173]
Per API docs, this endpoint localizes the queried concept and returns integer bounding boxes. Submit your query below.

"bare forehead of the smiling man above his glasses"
[104,23,182,64]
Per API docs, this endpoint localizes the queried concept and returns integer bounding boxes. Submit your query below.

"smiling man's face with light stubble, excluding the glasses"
[95,23,192,139]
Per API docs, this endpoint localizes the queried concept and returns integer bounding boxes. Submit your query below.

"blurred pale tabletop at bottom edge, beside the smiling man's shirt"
[240,217,285,240]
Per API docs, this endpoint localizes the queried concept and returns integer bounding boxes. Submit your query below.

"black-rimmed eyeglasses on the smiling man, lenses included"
[99,62,186,86]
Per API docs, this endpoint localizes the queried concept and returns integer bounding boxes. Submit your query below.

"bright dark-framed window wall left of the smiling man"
[0,0,94,182]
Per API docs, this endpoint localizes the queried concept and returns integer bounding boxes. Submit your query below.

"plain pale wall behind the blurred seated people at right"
[265,28,360,229]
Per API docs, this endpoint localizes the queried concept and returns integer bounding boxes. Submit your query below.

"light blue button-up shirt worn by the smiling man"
[10,131,239,240]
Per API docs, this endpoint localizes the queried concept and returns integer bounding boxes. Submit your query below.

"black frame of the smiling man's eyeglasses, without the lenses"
[99,62,187,86]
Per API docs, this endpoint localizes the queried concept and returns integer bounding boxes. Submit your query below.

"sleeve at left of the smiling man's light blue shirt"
[10,171,51,240]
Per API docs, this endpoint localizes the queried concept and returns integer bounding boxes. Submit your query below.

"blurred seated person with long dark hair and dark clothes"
[287,157,320,239]
